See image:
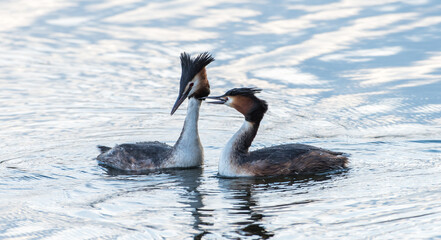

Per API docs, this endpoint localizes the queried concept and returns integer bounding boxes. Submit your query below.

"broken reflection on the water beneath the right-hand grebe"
[219,173,334,239]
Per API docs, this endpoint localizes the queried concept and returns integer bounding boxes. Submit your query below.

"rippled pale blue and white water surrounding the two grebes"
[0,0,441,239]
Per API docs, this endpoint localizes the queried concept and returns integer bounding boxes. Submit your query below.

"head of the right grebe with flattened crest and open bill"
[204,88,268,122]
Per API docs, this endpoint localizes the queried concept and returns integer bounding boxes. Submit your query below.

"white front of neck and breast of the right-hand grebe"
[219,121,254,177]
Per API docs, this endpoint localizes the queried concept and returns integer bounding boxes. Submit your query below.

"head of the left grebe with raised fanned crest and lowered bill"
[171,52,214,115]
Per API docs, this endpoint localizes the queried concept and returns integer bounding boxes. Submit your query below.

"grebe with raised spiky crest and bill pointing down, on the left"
[97,52,214,171]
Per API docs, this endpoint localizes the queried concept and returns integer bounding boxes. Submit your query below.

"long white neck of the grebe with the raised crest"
[173,98,204,167]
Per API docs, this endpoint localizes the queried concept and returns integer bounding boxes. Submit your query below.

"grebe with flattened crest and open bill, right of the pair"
[204,88,348,177]
